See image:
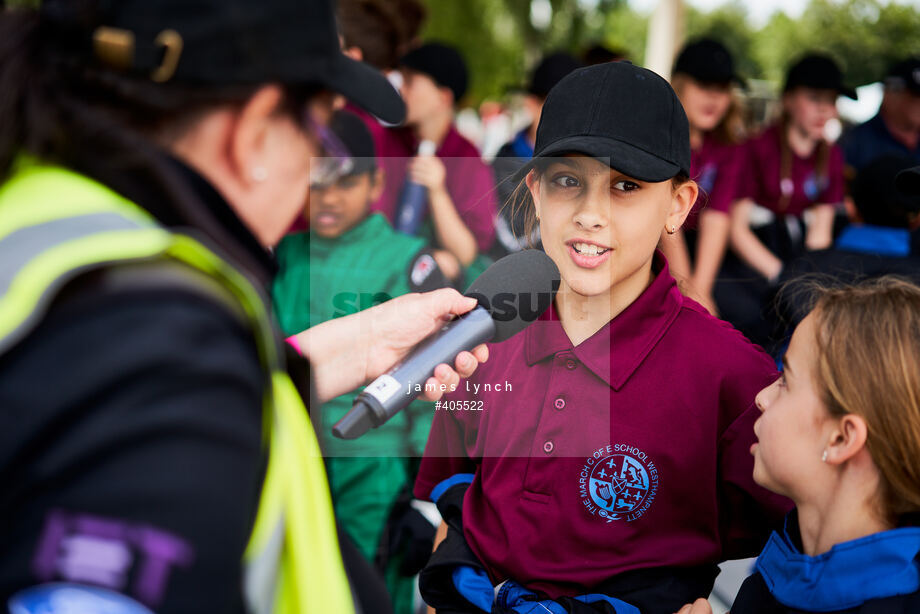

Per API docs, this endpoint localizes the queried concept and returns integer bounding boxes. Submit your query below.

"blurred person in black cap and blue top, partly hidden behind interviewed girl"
[489,52,581,260]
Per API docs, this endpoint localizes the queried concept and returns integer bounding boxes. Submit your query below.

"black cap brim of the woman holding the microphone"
[323,55,406,124]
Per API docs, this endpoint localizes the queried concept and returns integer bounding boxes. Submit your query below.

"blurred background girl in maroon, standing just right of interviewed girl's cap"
[661,38,744,315]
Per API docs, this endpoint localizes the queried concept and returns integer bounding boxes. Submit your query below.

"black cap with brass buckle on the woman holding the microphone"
[41,0,405,123]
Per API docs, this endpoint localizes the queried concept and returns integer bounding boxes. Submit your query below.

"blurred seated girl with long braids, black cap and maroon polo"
[716,54,856,345]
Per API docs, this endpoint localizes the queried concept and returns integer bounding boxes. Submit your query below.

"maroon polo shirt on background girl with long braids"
[738,125,845,217]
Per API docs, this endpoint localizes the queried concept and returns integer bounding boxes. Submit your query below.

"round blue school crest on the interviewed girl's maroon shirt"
[578,443,658,523]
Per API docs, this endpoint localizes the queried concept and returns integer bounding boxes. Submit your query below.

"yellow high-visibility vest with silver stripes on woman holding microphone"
[0,161,355,614]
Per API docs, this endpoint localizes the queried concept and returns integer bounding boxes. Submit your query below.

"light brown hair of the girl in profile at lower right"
[814,276,920,523]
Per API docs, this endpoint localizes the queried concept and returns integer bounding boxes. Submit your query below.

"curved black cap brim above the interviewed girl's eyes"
[514,136,689,183]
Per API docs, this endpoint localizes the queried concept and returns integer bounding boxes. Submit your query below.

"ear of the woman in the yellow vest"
[228,85,284,186]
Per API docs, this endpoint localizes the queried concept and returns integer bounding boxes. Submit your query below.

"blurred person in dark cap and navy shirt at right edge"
[841,57,920,171]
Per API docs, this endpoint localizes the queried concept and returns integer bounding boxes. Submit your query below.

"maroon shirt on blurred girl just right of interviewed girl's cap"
[684,134,744,228]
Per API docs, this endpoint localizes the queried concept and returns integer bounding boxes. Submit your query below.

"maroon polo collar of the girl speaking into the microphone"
[524,252,683,390]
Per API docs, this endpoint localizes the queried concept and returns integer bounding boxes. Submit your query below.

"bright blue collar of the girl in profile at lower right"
[756,511,920,612]
